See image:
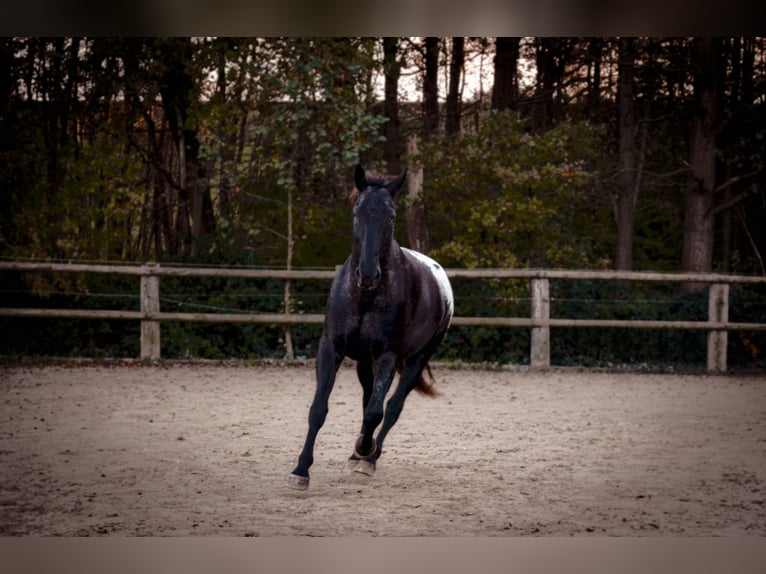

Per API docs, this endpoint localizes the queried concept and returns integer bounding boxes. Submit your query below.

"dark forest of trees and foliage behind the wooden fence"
[0,37,766,364]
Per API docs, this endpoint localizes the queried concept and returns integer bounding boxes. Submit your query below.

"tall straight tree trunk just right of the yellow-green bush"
[615,38,638,271]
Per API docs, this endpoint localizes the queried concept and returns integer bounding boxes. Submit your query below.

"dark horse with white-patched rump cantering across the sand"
[288,165,454,490]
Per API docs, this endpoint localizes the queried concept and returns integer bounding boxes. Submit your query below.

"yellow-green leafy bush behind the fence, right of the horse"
[419,111,607,274]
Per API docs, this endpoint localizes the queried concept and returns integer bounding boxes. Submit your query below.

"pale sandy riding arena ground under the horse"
[0,363,766,536]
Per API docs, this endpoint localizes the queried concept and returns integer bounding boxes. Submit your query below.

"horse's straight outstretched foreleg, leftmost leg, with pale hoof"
[287,336,343,490]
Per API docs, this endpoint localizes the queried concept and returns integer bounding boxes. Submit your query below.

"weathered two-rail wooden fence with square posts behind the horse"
[0,262,766,372]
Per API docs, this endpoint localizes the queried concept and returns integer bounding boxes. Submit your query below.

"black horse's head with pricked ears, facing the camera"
[352,165,407,291]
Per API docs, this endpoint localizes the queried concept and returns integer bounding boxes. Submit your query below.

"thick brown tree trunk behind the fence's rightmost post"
[681,38,720,291]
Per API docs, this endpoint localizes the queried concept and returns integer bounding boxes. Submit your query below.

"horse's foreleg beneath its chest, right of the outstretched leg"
[350,353,396,476]
